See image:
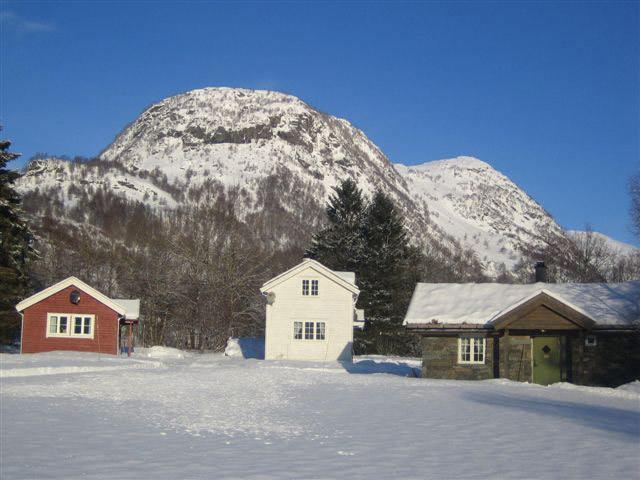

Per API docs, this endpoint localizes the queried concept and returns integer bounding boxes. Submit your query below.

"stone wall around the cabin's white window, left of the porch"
[422,336,493,380]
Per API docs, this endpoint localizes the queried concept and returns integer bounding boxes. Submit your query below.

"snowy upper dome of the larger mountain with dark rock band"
[100,88,404,209]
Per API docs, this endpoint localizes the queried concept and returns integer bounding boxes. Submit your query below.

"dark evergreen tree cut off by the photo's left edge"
[0,135,33,340]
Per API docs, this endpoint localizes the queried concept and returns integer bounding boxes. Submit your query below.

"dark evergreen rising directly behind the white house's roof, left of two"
[307,179,365,272]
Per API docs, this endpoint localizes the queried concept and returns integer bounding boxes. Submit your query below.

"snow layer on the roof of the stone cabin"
[404,281,640,325]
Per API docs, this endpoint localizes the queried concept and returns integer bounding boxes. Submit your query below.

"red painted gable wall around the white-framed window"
[22,286,119,355]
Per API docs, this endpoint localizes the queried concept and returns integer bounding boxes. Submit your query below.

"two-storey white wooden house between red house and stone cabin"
[260,259,364,361]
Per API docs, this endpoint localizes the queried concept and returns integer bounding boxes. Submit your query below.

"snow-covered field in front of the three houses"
[0,349,640,479]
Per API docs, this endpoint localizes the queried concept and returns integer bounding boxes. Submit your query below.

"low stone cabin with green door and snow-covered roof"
[404,274,640,387]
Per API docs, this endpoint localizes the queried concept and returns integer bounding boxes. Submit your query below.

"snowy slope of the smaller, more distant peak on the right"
[396,157,560,267]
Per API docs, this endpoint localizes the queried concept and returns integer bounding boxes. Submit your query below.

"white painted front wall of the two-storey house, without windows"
[265,262,354,361]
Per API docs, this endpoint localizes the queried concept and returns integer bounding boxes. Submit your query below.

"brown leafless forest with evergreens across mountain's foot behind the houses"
[2,141,640,354]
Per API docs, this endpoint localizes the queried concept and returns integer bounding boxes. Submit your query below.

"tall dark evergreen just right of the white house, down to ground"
[358,191,421,354]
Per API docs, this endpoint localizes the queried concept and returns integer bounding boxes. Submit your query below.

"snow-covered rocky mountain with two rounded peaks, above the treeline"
[18,88,561,273]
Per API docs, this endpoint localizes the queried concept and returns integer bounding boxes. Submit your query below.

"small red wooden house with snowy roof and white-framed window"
[16,277,140,355]
